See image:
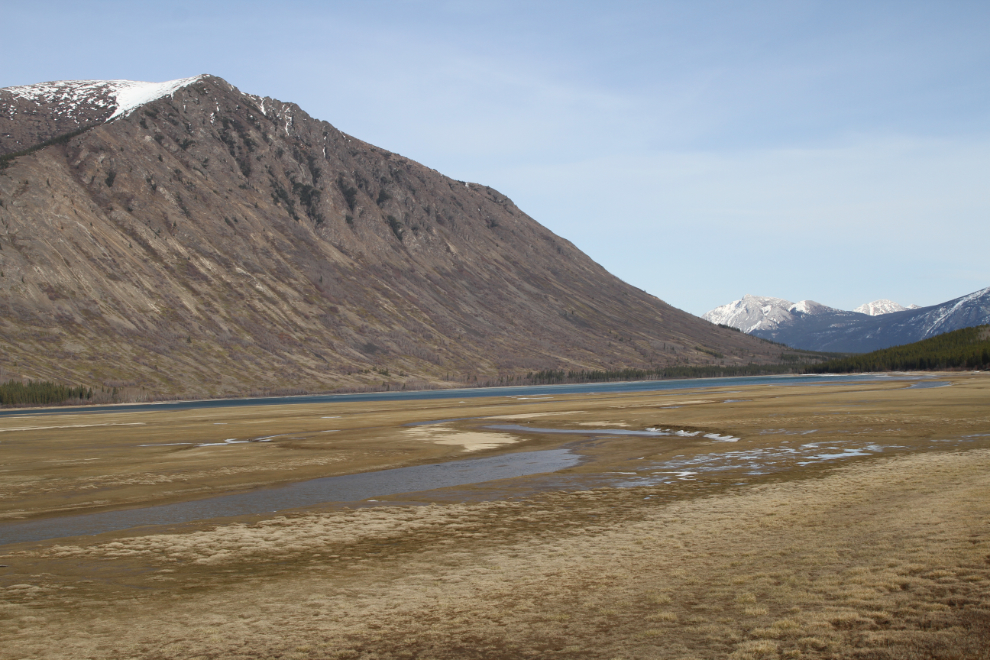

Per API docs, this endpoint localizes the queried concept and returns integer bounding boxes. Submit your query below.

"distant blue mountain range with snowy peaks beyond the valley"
[702,287,990,353]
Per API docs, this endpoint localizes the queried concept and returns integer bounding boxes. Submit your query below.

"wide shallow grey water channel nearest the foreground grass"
[0,449,582,545]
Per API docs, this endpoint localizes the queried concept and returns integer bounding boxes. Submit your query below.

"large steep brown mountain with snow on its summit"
[0,76,779,396]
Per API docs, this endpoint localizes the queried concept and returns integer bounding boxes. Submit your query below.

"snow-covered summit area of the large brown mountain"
[4,75,204,121]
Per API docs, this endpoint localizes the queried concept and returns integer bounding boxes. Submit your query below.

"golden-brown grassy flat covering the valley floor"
[0,373,990,660]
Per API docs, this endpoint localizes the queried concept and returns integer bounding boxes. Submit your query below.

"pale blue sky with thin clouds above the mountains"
[0,0,990,315]
